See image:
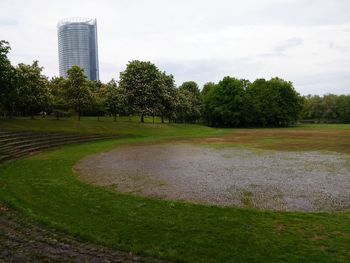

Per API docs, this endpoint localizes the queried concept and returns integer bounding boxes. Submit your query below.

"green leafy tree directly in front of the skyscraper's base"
[66,65,93,121]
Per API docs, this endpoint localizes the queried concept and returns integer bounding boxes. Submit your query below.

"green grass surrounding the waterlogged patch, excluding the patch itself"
[0,118,350,262]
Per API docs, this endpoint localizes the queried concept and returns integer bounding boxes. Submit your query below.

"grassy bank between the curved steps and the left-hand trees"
[0,117,223,137]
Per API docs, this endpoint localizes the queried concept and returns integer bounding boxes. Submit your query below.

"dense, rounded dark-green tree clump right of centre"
[202,77,301,127]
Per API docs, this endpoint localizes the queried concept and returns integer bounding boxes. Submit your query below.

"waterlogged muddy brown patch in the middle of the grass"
[74,143,350,211]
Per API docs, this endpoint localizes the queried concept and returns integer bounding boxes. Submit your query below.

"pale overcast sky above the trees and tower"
[0,0,350,95]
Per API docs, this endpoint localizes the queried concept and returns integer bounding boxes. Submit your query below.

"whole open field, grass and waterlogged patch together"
[0,118,350,262]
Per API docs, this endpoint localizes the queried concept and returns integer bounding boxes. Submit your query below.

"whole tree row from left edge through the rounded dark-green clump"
[0,41,349,127]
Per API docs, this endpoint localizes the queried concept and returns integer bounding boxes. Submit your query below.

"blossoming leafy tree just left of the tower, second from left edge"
[16,61,50,119]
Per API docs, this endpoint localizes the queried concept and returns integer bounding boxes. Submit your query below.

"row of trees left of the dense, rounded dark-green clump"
[0,41,201,125]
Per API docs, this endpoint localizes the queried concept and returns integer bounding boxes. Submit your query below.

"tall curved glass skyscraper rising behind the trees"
[57,18,99,80]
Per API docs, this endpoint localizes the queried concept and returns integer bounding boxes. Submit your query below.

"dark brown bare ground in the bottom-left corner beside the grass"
[0,203,166,263]
